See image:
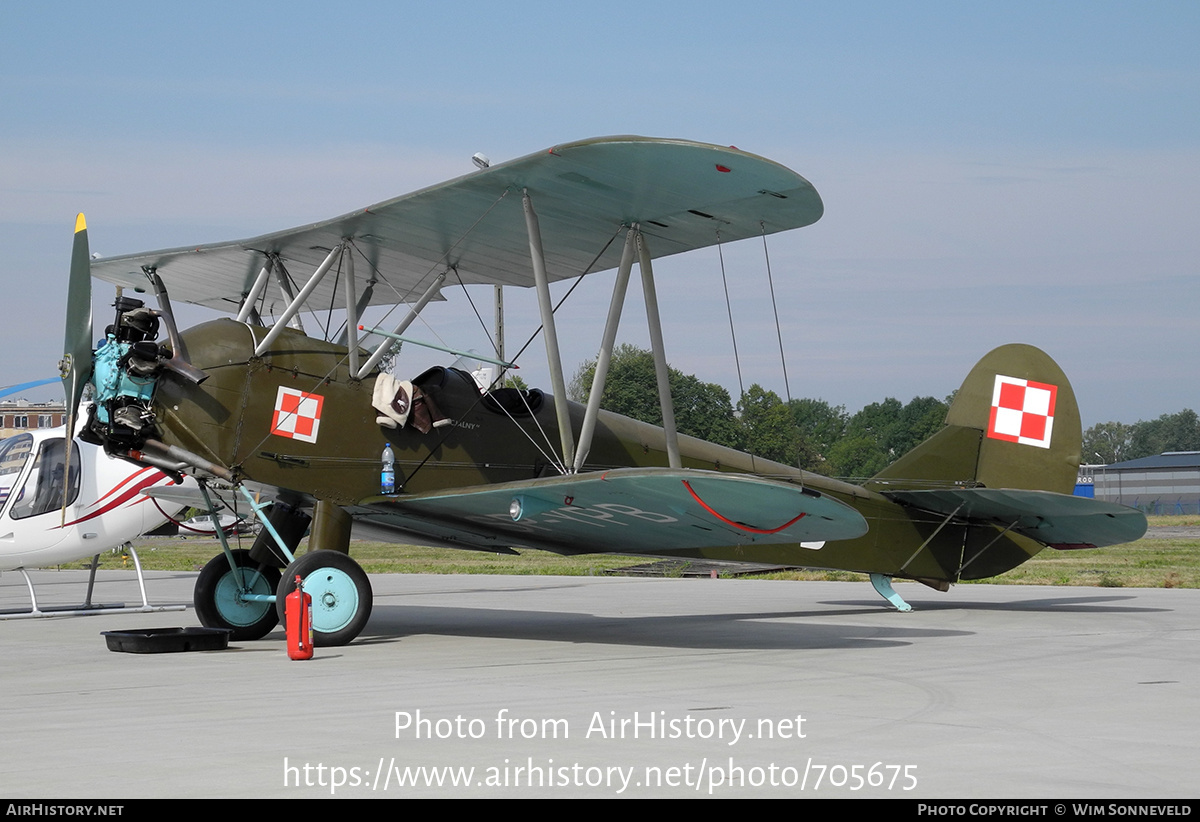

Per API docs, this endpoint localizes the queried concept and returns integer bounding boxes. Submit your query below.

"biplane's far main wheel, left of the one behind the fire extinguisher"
[192,551,280,641]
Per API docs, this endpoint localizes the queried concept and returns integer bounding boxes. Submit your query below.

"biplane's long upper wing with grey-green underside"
[91,137,823,311]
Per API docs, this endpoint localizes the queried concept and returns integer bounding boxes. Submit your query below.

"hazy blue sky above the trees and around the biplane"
[0,2,1200,425]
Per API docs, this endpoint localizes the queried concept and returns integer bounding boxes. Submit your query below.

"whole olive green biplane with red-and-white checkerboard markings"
[64,137,1146,644]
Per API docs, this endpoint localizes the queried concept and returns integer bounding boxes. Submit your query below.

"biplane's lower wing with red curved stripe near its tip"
[352,468,868,554]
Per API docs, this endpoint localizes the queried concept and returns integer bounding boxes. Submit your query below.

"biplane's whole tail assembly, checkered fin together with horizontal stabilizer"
[866,346,1146,581]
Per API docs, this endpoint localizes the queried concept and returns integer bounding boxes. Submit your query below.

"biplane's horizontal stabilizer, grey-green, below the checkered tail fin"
[883,488,1146,548]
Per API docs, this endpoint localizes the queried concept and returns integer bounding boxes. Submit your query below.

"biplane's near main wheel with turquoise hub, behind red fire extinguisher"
[275,551,373,648]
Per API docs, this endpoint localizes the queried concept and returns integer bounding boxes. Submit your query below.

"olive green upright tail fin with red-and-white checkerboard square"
[866,344,1082,494]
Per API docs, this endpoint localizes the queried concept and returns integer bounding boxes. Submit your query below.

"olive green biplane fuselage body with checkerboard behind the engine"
[140,319,1040,581]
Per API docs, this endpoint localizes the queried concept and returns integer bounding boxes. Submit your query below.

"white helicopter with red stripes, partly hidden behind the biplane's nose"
[0,379,182,619]
